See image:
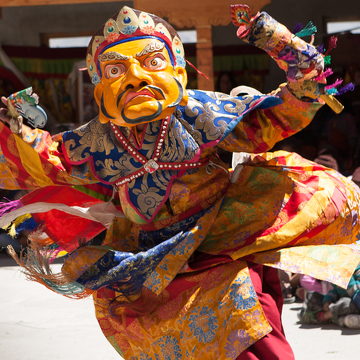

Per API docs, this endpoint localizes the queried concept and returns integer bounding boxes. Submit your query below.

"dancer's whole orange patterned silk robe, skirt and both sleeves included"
[0,86,360,360]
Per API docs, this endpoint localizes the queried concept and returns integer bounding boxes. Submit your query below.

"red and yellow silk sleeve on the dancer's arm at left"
[0,123,98,190]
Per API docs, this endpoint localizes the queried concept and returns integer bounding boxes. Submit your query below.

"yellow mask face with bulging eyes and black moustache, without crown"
[95,37,187,127]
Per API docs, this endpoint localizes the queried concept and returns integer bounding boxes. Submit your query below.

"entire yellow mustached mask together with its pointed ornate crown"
[86,6,187,127]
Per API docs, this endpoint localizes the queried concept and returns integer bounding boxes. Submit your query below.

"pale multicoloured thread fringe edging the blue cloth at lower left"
[8,243,93,299]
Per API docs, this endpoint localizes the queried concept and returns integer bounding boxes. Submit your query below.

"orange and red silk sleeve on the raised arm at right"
[218,84,322,153]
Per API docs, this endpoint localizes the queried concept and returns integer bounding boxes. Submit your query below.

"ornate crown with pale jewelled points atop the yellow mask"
[86,6,186,86]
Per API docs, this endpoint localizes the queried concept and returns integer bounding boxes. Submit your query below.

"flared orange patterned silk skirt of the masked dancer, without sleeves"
[65,151,360,359]
